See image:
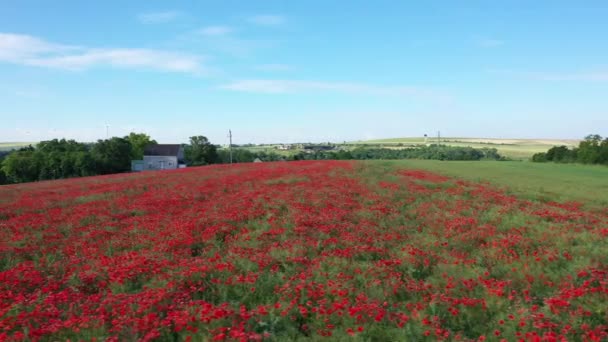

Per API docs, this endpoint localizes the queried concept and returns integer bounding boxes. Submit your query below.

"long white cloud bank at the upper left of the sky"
[0,33,203,73]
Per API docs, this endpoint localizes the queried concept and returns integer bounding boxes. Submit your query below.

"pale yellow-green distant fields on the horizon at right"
[353,137,579,160]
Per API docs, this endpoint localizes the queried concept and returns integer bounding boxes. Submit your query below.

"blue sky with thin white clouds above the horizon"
[0,0,608,144]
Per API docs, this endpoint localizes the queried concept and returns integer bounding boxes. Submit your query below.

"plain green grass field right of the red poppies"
[372,160,608,208]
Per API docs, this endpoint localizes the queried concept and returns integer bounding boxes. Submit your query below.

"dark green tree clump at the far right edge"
[532,134,608,165]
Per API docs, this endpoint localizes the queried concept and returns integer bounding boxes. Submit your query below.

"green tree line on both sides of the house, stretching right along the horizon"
[0,133,504,184]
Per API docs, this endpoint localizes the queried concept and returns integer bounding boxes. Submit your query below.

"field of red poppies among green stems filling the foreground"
[0,161,608,341]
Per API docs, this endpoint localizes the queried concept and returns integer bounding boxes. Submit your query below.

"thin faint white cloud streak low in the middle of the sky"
[220,80,448,100]
